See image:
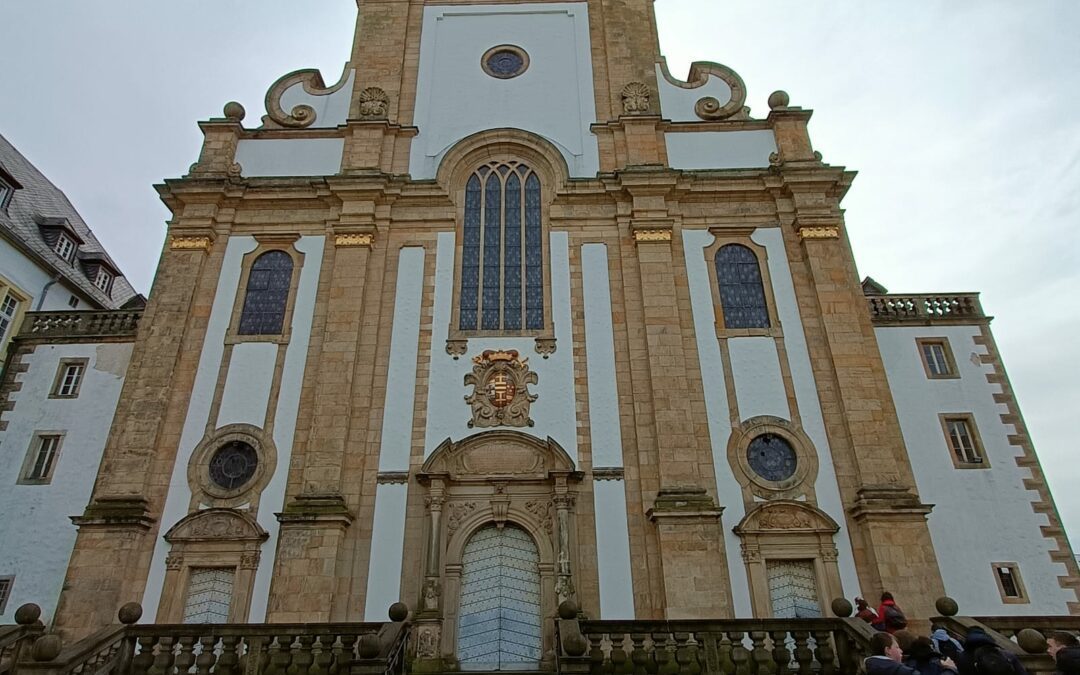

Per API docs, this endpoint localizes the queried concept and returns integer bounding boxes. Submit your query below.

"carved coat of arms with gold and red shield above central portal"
[465,349,537,429]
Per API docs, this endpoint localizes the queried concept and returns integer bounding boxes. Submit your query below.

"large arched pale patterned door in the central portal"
[458,525,542,671]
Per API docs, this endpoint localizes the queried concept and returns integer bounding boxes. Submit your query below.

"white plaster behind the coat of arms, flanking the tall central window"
[424,232,578,463]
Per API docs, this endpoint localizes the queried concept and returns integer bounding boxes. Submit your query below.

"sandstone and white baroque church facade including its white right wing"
[0,0,1080,670]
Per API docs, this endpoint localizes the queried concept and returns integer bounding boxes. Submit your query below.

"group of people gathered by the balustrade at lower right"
[855,593,1080,675]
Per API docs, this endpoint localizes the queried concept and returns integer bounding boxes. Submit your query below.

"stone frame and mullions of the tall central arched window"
[447,154,555,341]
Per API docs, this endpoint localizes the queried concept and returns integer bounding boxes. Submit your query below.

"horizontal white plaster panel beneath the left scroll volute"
[237,138,345,177]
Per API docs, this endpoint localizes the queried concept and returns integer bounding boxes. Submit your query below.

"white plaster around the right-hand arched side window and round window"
[683,228,859,618]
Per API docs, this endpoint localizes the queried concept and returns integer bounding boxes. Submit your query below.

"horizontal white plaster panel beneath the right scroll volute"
[665,129,777,173]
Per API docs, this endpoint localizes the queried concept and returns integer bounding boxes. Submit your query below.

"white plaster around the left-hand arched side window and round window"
[143,235,325,622]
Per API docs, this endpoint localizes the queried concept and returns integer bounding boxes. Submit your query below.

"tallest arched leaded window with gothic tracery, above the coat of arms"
[458,162,543,330]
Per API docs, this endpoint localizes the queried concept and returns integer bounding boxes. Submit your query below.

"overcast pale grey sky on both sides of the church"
[0,0,1080,546]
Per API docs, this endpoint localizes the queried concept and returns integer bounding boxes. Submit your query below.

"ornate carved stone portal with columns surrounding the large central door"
[415,432,581,670]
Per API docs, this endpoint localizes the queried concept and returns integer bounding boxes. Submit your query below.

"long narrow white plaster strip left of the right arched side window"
[683,230,754,619]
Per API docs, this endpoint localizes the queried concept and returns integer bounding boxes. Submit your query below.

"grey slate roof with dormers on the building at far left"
[0,135,141,309]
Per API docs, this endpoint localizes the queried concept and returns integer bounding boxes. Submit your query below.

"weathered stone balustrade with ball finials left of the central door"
[0,603,410,675]
